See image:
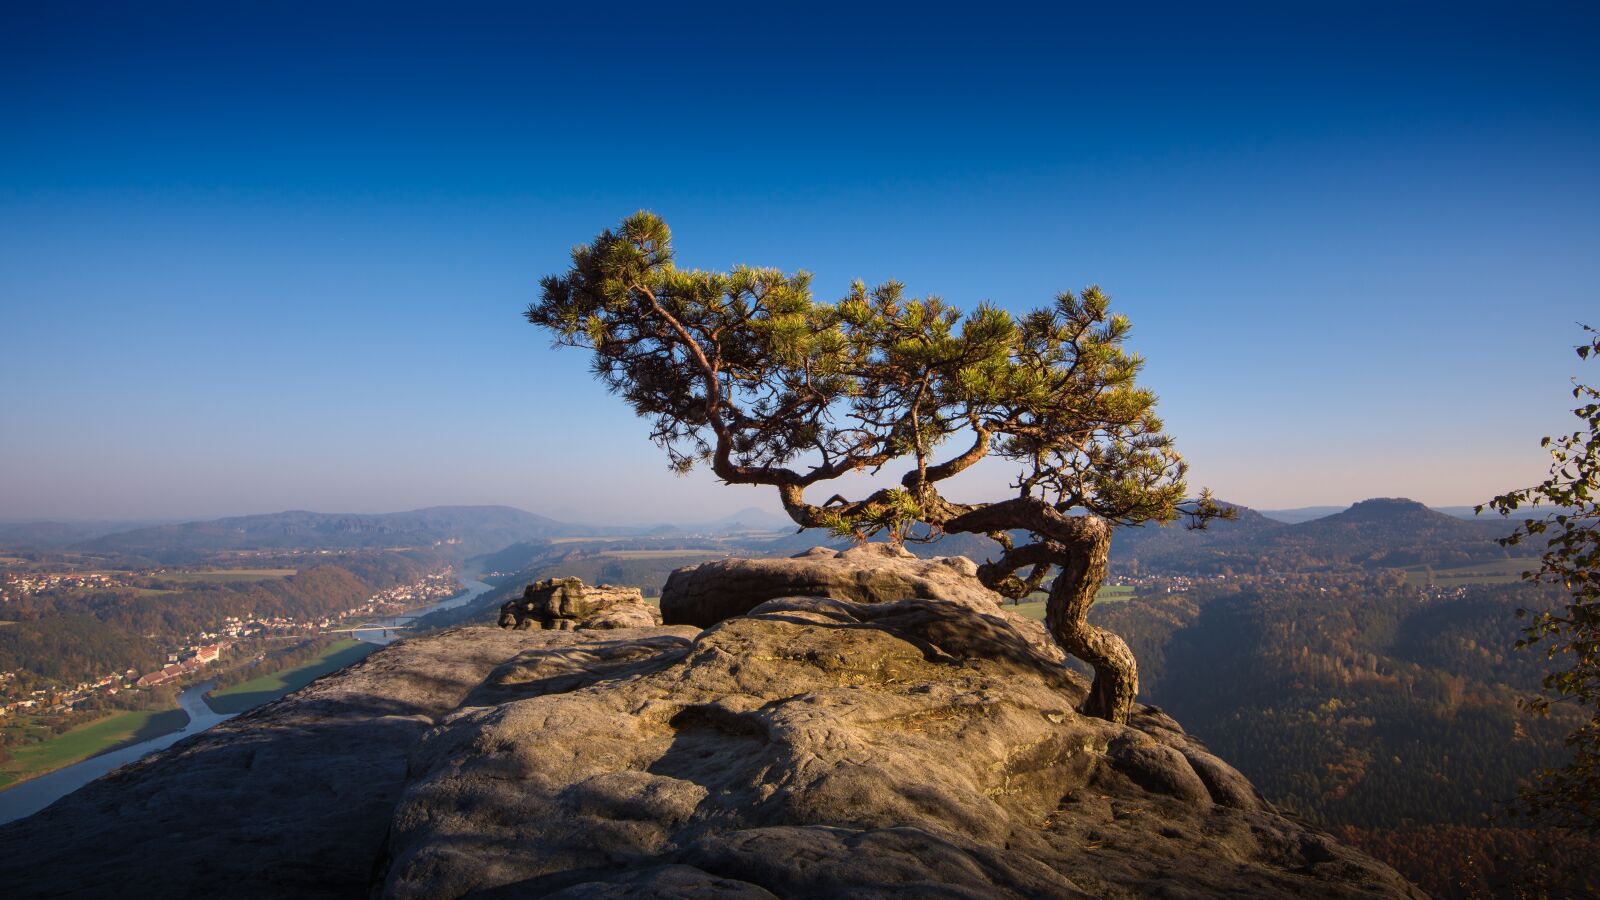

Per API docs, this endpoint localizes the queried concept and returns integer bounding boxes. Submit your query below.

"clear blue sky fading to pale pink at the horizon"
[0,2,1600,522]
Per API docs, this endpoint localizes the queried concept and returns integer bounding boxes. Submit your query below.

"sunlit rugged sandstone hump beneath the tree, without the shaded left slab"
[382,597,1418,897]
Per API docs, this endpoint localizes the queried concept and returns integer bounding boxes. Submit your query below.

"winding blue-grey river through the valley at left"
[0,580,493,825]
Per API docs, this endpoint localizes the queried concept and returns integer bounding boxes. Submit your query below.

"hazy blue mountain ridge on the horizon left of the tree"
[74,506,587,562]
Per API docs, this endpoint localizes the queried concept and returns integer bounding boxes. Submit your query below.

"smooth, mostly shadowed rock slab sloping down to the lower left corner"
[0,626,696,898]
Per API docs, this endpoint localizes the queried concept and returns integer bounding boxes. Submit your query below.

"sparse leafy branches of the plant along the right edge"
[1478,325,1600,831]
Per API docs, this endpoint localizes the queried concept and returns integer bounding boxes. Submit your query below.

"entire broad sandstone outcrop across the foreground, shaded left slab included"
[0,560,1421,898]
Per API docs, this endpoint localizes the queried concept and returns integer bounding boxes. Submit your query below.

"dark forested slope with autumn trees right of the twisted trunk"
[1096,570,1593,890]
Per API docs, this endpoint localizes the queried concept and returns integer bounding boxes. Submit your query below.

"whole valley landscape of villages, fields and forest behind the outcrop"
[0,500,1571,897]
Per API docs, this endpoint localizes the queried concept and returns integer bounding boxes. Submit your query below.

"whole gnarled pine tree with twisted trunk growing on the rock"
[526,211,1221,719]
